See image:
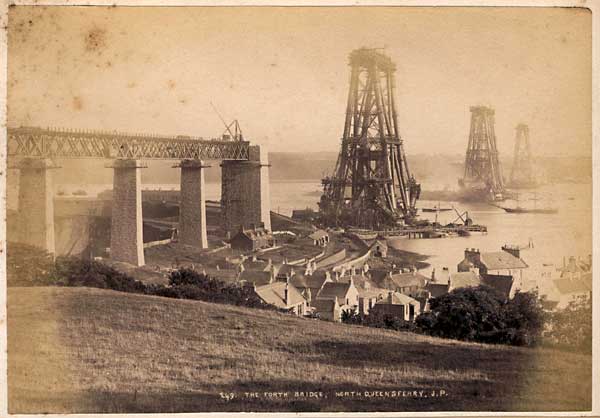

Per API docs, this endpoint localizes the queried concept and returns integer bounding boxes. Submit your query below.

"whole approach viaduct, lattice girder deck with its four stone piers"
[7,127,271,266]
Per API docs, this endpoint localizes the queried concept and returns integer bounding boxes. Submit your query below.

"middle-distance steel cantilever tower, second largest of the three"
[459,106,504,200]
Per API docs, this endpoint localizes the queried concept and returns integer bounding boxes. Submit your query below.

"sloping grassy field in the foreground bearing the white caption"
[8,288,592,413]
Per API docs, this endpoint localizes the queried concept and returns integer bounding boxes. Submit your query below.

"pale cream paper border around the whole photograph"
[0,0,600,417]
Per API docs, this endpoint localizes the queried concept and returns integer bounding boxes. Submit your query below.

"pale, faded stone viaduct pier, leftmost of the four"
[16,158,58,254]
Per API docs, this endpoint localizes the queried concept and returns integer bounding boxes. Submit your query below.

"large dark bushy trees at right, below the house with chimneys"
[416,286,545,345]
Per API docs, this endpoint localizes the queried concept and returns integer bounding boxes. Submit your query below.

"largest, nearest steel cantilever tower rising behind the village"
[319,48,420,228]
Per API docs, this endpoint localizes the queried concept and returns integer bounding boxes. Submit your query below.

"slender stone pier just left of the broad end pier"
[175,160,209,248]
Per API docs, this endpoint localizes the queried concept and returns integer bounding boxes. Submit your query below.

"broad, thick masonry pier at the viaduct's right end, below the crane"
[221,145,271,233]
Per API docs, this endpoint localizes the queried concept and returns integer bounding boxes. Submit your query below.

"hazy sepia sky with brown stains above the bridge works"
[8,6,591,156]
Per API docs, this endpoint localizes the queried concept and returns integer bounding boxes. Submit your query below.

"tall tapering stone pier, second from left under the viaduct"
[110,159,145,266]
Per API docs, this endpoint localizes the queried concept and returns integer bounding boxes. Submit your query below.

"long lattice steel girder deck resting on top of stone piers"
[7,128,250,160]
